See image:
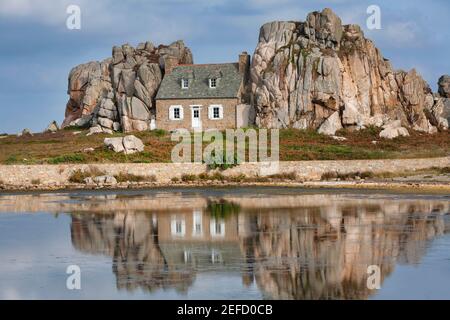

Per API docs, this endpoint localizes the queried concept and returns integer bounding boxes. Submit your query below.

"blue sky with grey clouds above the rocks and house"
[0,0,450,133]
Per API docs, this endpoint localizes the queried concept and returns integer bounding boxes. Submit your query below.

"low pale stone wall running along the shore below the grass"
[0,157,450,186]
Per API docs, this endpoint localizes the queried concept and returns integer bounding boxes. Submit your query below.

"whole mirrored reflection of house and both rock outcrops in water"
[68,196,450,299]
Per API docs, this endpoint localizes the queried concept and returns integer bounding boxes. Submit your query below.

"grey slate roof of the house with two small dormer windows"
[156,63,243,100]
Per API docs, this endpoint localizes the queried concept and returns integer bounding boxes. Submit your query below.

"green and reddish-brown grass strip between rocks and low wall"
[0,127,450,165]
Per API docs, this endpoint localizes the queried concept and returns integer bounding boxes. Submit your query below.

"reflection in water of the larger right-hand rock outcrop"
[242,205,450,299]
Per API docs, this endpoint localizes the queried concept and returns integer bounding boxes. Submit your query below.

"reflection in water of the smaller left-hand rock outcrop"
[72,213,193,292]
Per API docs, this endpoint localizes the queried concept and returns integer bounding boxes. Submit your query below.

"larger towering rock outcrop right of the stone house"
[251,9,448,135]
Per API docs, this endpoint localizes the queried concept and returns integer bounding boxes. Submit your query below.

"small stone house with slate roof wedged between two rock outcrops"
[155,52,254,131]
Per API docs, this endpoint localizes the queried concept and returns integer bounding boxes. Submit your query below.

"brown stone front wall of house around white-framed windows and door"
[156,98,238,131]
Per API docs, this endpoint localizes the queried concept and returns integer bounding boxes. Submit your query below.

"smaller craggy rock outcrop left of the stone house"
[62,41,193,133]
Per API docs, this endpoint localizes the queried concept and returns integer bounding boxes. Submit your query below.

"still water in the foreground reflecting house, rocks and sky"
[0,188,450,300]
